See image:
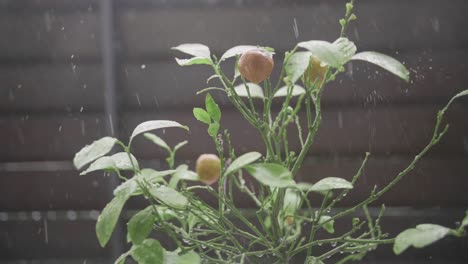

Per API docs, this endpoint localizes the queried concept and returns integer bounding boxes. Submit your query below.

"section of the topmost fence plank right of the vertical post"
[120,0,468,58]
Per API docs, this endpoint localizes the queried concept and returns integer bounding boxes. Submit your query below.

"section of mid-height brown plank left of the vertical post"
[0,114,106,161]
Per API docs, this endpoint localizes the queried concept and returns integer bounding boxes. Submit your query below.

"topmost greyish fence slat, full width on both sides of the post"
[0,0,468,59]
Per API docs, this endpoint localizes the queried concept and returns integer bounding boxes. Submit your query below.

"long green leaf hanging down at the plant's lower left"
[96,181,137,247]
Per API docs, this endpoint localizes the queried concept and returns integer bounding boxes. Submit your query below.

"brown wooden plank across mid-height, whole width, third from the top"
[0,102,468,161]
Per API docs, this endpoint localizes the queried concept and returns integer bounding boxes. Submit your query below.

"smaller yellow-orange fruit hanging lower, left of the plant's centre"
[195,154,221,185]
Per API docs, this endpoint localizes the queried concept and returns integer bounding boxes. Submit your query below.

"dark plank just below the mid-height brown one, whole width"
[0,156,468,211]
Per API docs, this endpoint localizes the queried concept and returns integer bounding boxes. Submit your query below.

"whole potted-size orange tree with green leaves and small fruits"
[74,2,468,264]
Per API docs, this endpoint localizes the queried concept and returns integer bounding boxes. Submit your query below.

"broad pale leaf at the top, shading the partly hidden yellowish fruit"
[297,40,346,68]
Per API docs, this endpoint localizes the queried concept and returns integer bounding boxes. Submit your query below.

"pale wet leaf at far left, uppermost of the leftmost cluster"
[73,137,117,169]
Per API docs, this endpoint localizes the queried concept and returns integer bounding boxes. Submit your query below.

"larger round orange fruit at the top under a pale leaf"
[237,49,274,84]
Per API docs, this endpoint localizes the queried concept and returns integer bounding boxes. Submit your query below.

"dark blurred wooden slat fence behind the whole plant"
[0,0,468,264]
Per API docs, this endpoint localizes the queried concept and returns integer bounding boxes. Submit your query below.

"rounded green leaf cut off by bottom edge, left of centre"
[131,238,165,264]
